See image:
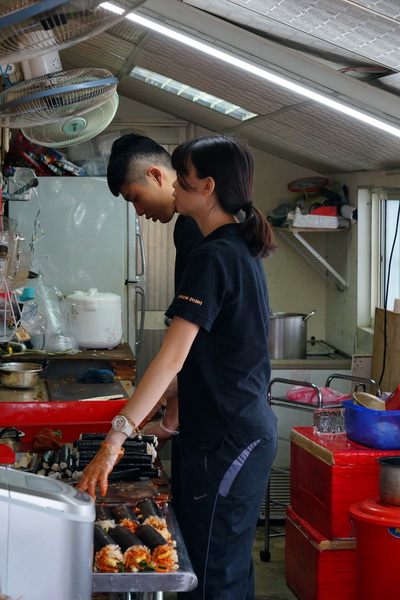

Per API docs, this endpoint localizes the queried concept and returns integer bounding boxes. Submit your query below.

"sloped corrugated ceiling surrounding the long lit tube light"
[17,0,400,174]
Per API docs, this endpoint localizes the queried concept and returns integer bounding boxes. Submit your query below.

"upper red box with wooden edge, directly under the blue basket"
[290,427,400,540]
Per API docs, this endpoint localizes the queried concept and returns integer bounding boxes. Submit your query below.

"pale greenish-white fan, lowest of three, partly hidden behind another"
[22,93,118,148]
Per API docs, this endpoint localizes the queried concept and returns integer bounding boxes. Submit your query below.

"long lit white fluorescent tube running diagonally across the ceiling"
[101,2,400,137]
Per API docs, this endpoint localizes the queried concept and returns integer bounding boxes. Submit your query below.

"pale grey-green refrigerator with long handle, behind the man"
[8,177,146,360]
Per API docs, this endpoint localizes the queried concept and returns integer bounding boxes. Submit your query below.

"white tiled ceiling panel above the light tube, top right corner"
[183,0,400,70]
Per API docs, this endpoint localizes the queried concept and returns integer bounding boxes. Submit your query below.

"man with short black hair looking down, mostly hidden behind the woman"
[107,133,203,512]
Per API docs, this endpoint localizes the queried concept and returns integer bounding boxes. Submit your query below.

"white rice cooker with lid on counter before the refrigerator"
[66,288,122,349]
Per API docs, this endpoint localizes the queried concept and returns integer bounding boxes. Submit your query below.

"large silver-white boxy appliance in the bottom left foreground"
[0,467,95,600]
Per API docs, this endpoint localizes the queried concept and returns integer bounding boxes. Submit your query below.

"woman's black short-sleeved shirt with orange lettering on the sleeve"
[166,224,275,448]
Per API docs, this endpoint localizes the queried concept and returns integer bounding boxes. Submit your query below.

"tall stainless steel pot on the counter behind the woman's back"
[269,310,316,359]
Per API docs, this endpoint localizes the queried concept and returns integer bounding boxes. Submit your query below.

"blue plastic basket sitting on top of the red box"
[343,400,400,450]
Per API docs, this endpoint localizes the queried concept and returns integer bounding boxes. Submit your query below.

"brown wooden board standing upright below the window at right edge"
[372,308,400,392]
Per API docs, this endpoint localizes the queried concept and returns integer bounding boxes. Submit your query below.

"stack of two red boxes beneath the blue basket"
[285,426,400,600]
